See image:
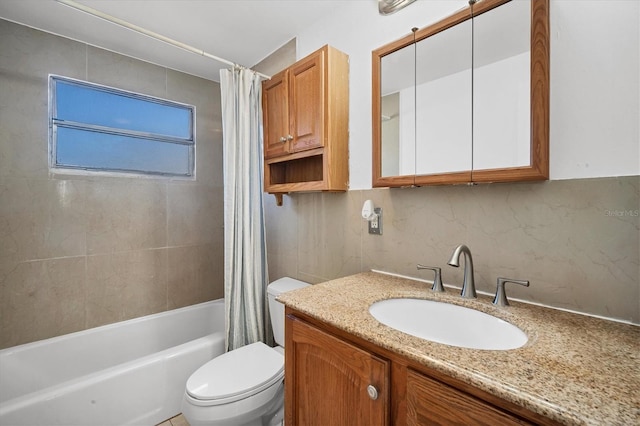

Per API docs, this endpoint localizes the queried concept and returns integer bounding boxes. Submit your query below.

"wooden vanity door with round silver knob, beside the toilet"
[285,316,389,426]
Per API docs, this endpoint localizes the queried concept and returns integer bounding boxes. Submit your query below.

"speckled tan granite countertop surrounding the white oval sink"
[278,272,640,425]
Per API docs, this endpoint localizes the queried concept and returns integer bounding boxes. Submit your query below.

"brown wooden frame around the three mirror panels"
[371,0,550,188]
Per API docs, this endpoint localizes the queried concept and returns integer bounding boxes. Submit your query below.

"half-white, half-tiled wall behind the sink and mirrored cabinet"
[265,0,640,323]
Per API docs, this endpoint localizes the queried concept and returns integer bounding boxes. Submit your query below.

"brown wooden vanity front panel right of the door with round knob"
[407,370,531,426]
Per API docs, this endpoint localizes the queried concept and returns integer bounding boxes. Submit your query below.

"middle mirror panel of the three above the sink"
[412,20,473,175]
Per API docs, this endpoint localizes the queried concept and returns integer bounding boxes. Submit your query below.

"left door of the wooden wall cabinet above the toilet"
[262,70,289,158]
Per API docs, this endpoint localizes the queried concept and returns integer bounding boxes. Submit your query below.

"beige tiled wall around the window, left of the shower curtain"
[0,20,224,348]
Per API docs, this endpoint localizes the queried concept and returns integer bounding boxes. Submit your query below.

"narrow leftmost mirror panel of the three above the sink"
[380,44,416,176]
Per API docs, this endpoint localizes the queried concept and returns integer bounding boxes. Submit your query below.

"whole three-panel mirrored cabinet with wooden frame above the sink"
[372,0,549,187]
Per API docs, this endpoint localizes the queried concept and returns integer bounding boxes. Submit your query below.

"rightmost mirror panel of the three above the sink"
[473,0,531,170]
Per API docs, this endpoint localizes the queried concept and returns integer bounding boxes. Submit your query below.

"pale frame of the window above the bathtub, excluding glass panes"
[47,74,196,180]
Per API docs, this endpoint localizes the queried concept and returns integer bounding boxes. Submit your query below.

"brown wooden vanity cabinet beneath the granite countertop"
[285,307,556,426]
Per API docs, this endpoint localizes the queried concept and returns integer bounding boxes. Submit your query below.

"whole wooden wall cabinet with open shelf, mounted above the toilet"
[262,46,349,204]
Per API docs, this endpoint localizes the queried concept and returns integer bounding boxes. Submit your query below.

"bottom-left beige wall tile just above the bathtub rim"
[0,257,86,349]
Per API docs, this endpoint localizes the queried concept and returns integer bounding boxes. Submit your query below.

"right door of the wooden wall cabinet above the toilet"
[289,51,325,152]
